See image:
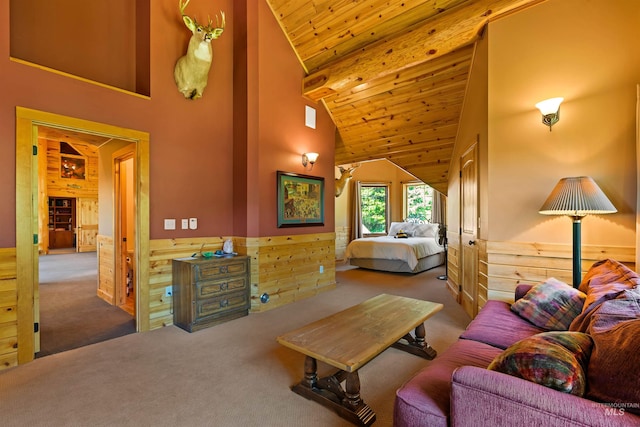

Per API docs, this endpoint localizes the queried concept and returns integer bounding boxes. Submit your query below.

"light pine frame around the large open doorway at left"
[16,107,149,364]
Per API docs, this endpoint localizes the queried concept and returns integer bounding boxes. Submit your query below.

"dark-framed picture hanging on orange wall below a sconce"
[277,171,324,228]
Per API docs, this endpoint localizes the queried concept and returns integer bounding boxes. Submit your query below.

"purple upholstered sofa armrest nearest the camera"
[451,366,640,427]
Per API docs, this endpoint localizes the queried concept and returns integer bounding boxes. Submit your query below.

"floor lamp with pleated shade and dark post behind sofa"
[540,176,617,288]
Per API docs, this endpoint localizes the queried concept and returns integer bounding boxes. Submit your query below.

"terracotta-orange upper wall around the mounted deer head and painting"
[0,0,334,247]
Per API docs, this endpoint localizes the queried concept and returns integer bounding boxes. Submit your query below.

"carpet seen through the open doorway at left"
[36,252,136,358]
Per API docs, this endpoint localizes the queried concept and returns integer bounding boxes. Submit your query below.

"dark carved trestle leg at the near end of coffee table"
[291,356,376,426]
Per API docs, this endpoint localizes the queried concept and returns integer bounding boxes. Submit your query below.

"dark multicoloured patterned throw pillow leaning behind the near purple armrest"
[488,331,593,396]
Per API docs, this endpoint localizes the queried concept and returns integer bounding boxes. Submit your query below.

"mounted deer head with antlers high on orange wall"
[173,0,225,99]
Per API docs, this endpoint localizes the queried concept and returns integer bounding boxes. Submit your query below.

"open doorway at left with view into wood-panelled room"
[36,130,136,358]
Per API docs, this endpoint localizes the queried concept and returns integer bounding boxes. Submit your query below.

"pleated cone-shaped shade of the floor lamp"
[540,176,617,218]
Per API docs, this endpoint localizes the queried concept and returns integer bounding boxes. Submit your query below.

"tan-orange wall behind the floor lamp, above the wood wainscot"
[486,0,640,247]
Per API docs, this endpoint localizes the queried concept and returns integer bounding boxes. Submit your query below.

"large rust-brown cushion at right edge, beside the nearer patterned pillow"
[587,288,640,414]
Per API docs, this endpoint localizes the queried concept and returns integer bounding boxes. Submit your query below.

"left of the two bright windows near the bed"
[360,184,389,235]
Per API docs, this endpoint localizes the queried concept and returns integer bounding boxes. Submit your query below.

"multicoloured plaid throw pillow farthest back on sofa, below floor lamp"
[511,277,586,331]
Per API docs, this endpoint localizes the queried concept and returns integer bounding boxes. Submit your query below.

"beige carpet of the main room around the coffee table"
[0,268,470,427]
